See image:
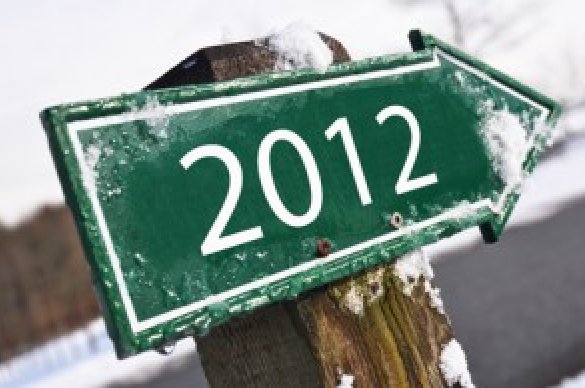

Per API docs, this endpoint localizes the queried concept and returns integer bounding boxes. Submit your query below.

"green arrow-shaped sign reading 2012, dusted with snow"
[41,34,559,357]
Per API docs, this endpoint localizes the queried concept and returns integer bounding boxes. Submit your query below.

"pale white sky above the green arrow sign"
[0,0,585,226]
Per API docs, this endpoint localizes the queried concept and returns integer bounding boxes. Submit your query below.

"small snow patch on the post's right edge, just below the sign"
[393,249,445,315]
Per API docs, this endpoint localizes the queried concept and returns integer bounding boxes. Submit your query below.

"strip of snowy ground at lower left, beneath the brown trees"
[0,319,196,388]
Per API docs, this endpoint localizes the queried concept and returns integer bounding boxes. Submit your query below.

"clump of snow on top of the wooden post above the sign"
[267,22,333,71]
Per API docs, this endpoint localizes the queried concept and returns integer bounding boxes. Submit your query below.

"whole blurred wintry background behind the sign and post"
[0,0,585,387]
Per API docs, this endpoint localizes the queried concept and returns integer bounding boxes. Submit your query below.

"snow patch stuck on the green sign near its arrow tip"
[482,108,530,187]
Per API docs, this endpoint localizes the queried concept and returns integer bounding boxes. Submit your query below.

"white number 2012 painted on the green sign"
[180,105,437,256]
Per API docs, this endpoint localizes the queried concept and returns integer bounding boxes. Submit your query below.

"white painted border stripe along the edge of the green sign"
[67,48,548,333]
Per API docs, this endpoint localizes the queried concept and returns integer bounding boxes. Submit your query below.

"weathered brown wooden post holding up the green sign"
[148,34,452,388]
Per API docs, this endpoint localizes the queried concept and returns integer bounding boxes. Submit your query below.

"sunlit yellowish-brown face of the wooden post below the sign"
[297,265,452,387]
